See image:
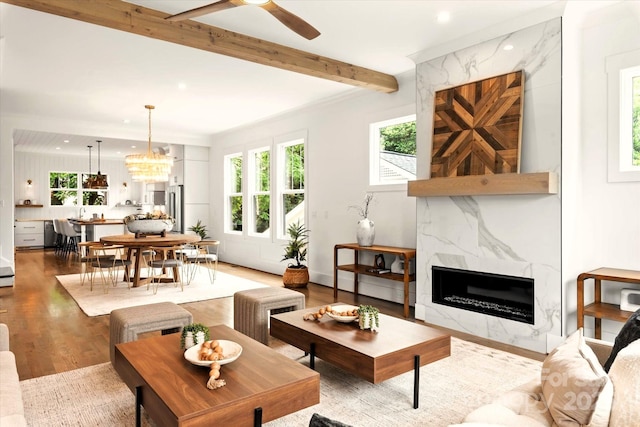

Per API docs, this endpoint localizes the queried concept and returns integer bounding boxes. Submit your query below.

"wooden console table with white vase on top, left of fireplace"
[333,243,416,317]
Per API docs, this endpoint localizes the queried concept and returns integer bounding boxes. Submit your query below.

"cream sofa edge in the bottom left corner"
[0,323,27,427]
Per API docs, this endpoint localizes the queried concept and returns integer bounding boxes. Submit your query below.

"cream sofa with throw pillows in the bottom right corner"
[450,330,640,427]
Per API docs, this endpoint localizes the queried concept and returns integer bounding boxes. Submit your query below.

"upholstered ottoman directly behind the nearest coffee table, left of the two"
[109,302,193,364]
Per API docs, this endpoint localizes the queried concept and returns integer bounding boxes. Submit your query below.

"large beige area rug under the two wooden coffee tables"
[20,338,541,427]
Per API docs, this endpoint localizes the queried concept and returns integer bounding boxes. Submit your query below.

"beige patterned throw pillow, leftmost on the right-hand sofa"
[541,328,609,427]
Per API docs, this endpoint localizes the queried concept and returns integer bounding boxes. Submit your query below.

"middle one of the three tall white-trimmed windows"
[248,147,271,237]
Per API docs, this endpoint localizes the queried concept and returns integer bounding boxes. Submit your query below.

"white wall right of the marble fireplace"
[563,2,640,340]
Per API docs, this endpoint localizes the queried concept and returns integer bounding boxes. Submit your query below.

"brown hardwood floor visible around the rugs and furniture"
[0,250,544,380]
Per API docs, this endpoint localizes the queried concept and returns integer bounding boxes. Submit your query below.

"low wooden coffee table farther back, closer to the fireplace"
[271,303,451,408]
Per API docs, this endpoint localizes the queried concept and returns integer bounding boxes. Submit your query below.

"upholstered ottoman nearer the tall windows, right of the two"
[233,287,305,344]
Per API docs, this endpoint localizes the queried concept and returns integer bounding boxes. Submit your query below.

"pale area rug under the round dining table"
[56,266,267,316]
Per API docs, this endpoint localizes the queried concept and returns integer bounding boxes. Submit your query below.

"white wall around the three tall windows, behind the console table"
[210,73,415,302]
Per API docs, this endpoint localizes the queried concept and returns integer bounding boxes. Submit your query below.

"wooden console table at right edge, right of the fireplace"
[577,268,640,339]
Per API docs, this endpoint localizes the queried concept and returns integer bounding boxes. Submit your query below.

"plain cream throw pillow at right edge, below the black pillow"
[609,339,640,427]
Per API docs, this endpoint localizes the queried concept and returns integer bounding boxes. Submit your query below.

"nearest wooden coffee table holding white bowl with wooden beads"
[114,325,320,426]
